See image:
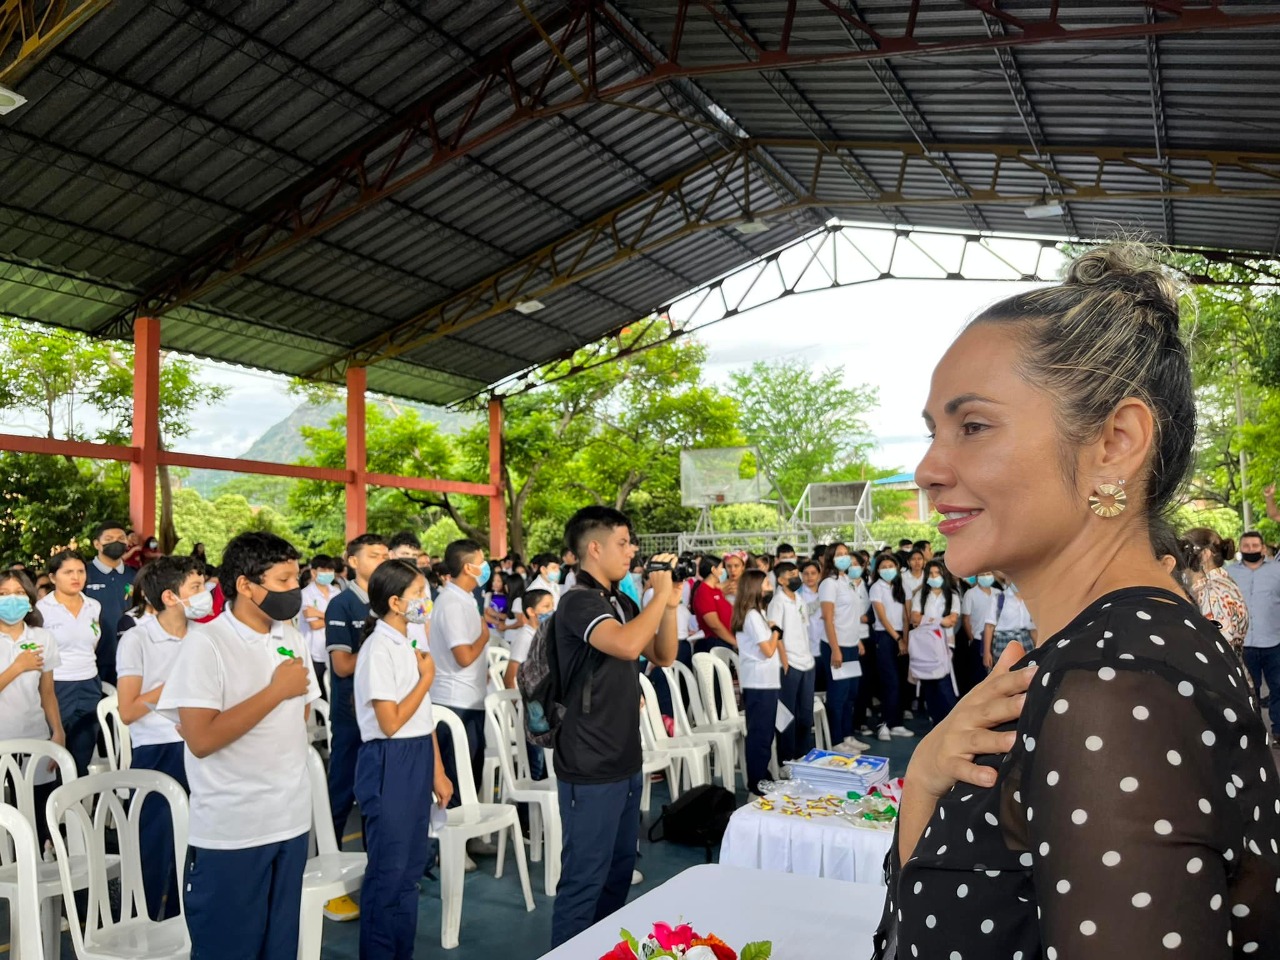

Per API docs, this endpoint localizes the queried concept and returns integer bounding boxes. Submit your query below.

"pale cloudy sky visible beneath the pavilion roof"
[0,280,1033,470]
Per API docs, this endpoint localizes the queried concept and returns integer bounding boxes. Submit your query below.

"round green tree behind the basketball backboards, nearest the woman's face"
[730,360,878,504]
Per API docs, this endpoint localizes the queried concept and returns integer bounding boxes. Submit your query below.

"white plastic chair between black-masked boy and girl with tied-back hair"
[298,752,369,960]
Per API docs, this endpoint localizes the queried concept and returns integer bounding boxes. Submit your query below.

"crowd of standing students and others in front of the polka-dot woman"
[0,508,1280,957]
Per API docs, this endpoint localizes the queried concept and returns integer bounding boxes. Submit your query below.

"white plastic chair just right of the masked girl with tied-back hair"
[431,705,534,950]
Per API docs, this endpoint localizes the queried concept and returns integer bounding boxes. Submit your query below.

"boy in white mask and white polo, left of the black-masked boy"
[115,556,214,920]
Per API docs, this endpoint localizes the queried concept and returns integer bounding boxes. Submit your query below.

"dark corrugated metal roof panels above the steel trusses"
[0,0,1280,403]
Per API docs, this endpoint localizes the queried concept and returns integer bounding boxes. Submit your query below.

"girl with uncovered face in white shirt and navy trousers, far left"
[36,550,102,777]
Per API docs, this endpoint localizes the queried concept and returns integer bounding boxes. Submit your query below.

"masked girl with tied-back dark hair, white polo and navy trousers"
[355,559,453,960]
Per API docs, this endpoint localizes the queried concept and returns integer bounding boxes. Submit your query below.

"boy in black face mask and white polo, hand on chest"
[160,532,320,960]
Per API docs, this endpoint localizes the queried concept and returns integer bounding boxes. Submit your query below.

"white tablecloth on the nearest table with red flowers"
[543,864,884,960]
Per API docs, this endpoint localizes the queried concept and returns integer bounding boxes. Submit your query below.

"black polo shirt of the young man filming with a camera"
[554,571,644,783]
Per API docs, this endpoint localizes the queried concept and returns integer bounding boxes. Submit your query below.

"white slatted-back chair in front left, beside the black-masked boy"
[47,771,186,960]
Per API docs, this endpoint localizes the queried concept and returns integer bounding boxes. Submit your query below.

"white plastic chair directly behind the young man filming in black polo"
[484,690,561,897]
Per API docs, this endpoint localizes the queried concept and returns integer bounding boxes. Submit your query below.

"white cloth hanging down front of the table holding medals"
[721,804,893,883]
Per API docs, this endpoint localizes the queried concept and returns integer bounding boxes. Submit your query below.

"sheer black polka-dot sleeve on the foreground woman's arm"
[1019,666,1254,960]
